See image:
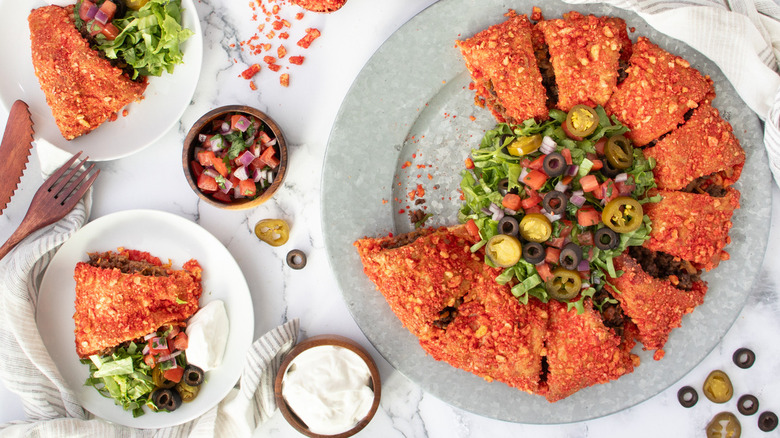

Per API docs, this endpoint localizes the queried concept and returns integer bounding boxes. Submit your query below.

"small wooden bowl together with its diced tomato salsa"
[182,105,287,210]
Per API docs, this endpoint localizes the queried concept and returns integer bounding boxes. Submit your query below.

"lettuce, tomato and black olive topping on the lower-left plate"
[81,324,204,417]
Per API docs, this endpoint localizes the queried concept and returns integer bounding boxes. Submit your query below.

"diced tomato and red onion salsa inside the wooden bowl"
[190,112,281,203]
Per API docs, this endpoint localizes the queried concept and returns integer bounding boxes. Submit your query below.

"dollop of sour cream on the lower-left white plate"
[186,300,230,371]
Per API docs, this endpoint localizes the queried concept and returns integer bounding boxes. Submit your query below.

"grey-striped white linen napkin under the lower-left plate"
[0,141,299,437]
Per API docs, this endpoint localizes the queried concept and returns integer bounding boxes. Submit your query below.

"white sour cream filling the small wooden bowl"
[282,345,374,435]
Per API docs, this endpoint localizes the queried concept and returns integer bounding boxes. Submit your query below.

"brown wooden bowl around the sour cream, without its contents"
[274,335,382,438]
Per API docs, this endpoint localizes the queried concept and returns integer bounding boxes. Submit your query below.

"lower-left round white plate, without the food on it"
[36,210,254,429]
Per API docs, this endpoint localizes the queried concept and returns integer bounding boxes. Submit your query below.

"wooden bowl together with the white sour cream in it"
[274,335,382,438]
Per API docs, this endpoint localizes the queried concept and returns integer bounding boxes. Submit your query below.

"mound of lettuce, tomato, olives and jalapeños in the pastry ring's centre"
[459,105,659,312]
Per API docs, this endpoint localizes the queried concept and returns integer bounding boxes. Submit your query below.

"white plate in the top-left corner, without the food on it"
[0,0,203,161]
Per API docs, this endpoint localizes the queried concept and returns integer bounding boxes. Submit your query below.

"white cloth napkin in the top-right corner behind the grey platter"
[564,0,780,181]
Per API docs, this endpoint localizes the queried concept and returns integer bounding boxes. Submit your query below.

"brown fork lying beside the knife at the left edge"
[0,151,100,259]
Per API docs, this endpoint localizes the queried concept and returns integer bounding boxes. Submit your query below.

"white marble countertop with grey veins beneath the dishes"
[0,0,780,438]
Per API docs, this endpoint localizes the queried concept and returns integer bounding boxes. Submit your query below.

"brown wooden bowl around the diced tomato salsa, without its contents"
[181,105,287,210]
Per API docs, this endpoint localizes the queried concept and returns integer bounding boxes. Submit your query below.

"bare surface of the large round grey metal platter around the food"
[322,0,771,424]
